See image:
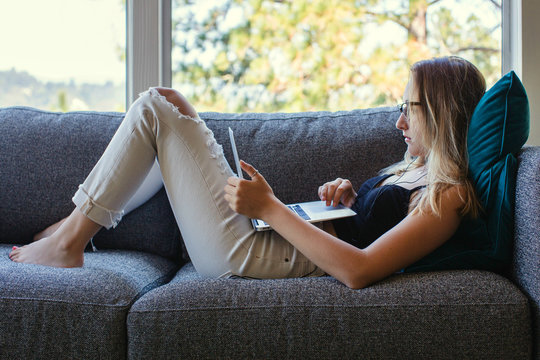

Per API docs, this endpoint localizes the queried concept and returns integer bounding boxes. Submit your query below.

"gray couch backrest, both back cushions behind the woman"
[0,107,405,258]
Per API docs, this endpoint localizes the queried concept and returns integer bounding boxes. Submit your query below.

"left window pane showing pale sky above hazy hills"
[0,0,126,111]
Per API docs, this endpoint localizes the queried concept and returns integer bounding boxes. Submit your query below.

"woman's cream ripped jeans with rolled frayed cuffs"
[73,89,324,278]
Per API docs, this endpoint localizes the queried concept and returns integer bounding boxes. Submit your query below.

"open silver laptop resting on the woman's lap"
[229,128,356,231]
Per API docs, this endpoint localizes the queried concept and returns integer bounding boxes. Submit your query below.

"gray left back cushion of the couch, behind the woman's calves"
[0,107,181,259]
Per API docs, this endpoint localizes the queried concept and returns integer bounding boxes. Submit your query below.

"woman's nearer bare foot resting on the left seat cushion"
[9,235,84,268]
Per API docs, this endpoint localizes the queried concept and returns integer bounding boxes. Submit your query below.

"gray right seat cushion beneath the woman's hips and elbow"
[128,265,531,360]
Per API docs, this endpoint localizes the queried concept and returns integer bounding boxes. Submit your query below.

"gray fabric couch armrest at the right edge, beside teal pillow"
[512,146,540,359]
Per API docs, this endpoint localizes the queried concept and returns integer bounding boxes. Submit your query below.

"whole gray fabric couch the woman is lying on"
[0,103,540,360]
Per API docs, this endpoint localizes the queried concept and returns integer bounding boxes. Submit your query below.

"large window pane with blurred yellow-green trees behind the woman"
[171,0,501,112]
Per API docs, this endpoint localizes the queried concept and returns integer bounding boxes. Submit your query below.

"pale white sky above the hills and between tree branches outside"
[0,0,498,84]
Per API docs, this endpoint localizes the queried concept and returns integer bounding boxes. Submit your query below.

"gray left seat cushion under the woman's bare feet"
[0,244,177,359]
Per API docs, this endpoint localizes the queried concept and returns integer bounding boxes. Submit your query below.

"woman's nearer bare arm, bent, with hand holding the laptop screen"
[226,163,462,289]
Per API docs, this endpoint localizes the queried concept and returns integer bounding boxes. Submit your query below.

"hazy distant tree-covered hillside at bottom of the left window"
[0,69,126,111]
